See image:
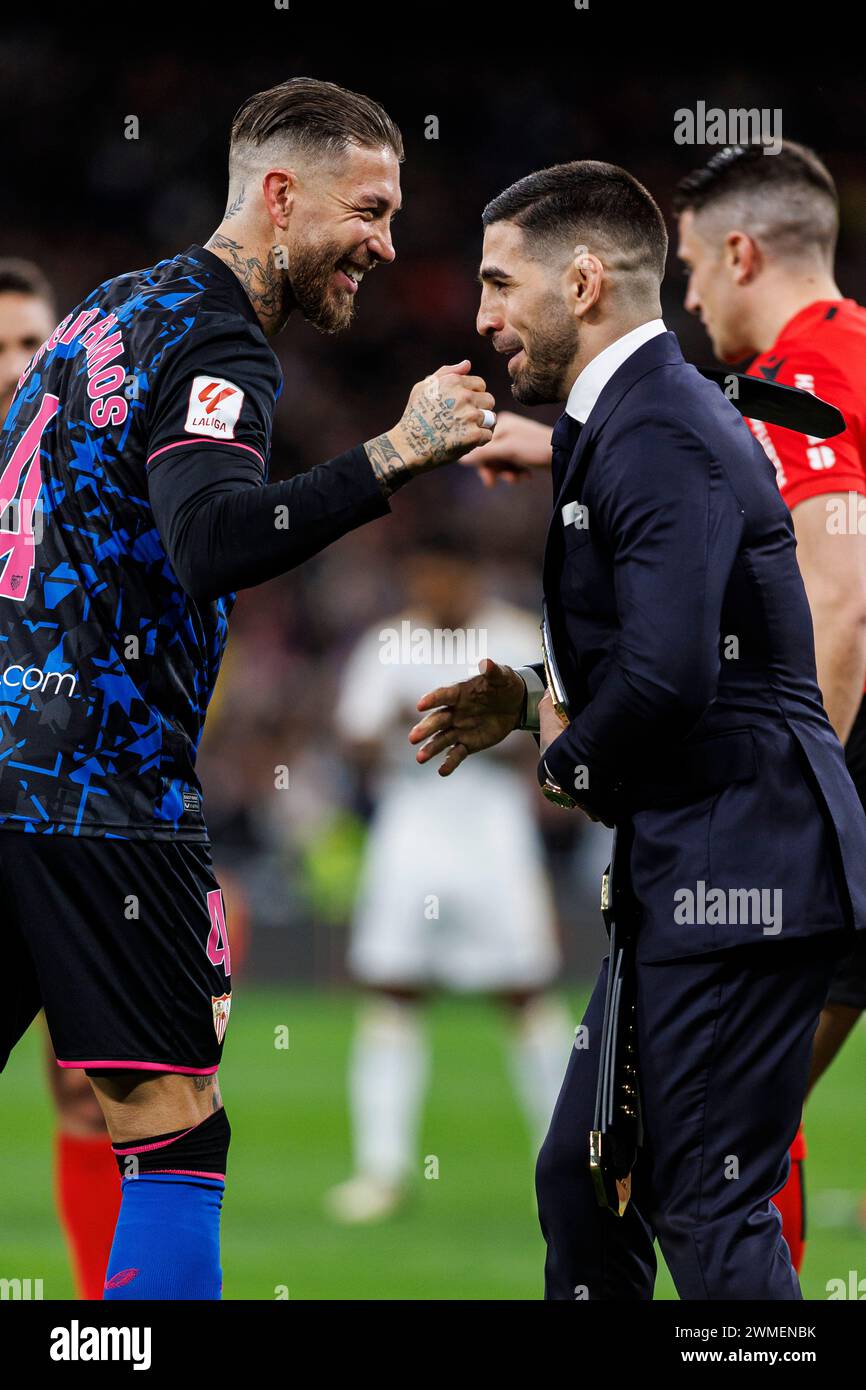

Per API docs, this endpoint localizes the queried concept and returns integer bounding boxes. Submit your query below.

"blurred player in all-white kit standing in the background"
[327,541,571,1223]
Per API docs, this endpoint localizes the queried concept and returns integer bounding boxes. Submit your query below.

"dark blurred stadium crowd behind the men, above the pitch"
[6,38,866,983]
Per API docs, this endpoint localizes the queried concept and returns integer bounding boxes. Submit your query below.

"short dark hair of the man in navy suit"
[481,160,667,281]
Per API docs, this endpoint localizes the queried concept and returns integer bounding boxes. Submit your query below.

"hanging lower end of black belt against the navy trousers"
[589,824,644,1216]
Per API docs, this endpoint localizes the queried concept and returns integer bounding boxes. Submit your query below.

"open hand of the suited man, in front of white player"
[409,657,525,777]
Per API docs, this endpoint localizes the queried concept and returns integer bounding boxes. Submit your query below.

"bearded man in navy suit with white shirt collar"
[410,161,866,1300]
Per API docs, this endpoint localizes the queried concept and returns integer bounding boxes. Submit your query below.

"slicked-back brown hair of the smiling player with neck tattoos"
[231,78,403,160]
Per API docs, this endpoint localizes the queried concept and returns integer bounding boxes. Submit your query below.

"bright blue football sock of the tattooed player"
[104,1173,225,1301]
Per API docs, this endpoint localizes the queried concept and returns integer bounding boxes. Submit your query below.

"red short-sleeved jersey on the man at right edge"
[748,299,866,695]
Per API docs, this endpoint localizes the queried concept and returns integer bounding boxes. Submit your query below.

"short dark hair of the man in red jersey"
[673,140,840,257]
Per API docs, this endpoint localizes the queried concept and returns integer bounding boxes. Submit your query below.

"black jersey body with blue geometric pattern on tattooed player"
[0,254,262,840]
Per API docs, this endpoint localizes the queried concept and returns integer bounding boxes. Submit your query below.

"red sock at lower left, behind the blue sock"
[54,1133,121,1300]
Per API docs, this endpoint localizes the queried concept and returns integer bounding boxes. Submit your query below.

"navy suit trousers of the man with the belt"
[537,931,851,1300]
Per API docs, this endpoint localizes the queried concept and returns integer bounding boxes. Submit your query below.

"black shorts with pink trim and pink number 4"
[0,830,232,1076]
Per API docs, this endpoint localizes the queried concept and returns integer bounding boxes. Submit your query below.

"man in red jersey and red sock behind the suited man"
[674,142,866,1270]
